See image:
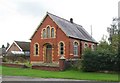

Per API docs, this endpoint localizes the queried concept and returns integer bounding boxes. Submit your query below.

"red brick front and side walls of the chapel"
[30,16,97,62]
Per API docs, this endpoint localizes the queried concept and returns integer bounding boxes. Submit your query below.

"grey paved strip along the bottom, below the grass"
[2,76,118,83]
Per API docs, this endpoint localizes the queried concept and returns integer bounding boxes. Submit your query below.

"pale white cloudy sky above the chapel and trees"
[0,0,119,47]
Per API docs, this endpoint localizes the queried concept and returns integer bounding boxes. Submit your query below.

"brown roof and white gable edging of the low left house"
[6,41,30,51]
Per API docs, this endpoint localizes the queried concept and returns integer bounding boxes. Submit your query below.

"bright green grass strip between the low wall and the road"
[2,66,118,81]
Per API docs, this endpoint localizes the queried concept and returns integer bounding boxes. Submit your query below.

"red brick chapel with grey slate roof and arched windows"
[30,12,97,64]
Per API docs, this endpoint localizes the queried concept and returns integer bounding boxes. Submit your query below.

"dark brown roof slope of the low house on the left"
[15,41,30,51]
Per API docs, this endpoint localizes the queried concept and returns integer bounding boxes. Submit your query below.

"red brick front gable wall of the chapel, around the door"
[30,16,69,61]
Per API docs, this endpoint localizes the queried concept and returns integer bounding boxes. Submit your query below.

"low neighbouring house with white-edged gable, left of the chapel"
[6,41,30,57]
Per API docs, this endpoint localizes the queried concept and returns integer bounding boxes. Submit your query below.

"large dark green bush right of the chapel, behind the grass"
[82,49,119,71]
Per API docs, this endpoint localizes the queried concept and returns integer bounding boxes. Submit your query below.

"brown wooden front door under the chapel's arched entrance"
[46,44,52,63]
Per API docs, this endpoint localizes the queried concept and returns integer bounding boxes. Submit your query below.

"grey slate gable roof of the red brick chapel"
[31,12,97,43]
